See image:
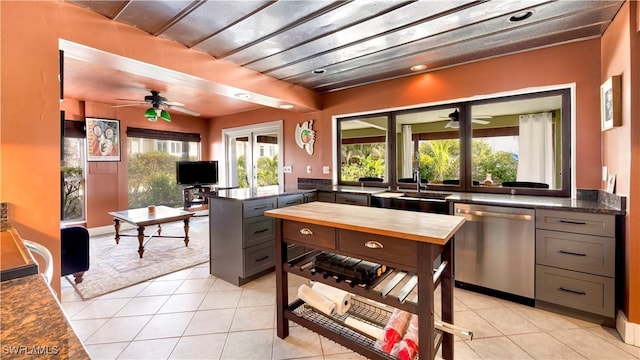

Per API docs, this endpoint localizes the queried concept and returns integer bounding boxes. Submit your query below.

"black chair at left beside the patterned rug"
[60,226,89,284]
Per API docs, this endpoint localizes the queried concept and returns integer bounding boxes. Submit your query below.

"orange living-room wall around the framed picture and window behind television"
[61,99,210,228]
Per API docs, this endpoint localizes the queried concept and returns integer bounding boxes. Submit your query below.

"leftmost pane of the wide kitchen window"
[338,115,389,183]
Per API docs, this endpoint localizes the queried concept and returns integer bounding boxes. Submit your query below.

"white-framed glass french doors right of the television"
[221,121,284,191]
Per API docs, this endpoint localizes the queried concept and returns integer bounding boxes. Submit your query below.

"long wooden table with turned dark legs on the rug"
[109,206,193,258]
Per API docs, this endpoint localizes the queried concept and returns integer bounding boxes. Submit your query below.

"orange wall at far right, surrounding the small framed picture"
[600,2,640,323]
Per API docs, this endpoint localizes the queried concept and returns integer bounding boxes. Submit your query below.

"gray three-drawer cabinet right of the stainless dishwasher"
[536,210,616,322]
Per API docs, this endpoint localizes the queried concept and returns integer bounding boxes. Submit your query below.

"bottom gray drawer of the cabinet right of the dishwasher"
[536,265,615,317]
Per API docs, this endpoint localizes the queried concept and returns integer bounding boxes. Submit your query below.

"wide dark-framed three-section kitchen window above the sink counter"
[337,89,571,196]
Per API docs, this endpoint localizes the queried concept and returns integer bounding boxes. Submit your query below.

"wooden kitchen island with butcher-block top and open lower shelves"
[264,202,464,359]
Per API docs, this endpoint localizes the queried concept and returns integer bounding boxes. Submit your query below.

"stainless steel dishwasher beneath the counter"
[454,204,535,301]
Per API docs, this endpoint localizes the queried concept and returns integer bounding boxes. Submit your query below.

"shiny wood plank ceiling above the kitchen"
[62,0,623,115]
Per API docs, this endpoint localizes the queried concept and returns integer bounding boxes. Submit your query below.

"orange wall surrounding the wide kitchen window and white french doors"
[209,40,601,189]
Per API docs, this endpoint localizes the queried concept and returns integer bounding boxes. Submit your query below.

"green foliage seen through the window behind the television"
[128,152,183,208]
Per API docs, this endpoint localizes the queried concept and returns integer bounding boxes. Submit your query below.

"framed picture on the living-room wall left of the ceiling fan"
[85,118,120,161]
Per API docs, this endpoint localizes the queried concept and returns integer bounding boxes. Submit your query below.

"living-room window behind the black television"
[127,128,200,208]
